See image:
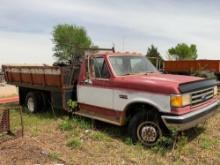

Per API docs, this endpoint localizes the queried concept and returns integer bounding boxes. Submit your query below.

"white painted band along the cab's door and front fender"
[77,85,171,112]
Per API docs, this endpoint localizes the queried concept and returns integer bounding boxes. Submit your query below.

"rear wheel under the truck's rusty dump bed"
[25,92,40,113]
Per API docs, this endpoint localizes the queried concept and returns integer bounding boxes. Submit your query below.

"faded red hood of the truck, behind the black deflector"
[114,73,202,94]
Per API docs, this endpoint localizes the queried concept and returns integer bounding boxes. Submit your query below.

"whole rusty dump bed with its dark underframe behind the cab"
[2,65,78,110]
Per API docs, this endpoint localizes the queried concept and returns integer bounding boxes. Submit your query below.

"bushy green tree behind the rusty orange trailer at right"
[168,43,197,60]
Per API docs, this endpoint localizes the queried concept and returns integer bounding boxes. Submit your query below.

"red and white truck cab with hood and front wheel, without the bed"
[76,53,219,145]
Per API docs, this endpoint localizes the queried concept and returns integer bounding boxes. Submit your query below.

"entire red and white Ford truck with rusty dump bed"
[3,52,219,146]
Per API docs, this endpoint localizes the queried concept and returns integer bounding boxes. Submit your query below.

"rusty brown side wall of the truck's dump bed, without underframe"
[2,65,72,90]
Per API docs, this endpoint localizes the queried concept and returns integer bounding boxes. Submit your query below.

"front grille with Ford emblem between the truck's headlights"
[191,87,214,106]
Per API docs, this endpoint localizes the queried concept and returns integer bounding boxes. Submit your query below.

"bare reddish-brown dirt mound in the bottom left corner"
[0,137,65,165]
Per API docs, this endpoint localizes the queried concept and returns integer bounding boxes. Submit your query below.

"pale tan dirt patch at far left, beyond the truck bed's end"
[0,84,18,98]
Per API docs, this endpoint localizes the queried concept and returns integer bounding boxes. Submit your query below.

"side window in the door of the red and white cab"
[90,57,110,78]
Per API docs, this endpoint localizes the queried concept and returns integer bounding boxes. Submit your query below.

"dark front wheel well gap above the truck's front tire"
[124,103,160,123]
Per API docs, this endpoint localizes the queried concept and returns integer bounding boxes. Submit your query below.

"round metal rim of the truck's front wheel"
[137,121,161,145]
